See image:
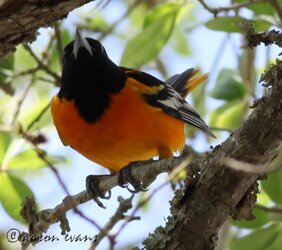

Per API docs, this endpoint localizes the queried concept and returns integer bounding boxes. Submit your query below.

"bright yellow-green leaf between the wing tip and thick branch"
[216,102,246,129]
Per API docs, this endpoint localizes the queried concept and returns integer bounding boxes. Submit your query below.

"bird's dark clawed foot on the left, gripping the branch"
[86,174,112,208]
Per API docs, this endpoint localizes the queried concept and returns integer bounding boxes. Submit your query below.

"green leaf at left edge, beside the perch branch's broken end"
[0,172,33,222]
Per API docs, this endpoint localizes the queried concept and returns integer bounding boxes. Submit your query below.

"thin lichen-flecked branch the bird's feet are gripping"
[21,148,199,247]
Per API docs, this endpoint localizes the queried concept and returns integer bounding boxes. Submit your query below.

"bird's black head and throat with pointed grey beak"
[58,31,125,122]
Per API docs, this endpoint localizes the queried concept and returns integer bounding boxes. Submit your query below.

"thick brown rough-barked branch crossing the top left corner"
[0,0,94,57]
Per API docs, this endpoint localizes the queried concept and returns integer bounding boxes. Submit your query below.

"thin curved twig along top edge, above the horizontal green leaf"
[198,0,270,17]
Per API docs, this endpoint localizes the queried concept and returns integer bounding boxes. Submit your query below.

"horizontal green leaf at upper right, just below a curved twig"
[205,16,272,33]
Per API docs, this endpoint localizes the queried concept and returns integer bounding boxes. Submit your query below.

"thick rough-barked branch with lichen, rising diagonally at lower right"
[145,61,282,250]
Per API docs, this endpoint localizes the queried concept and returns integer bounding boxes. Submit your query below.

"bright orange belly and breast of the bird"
[51,86,185,171]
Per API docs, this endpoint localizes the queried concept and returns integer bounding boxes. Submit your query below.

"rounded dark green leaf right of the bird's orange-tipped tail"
[210,69,247,100]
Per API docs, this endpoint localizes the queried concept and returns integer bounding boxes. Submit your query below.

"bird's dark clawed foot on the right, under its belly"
[118,160,152,193]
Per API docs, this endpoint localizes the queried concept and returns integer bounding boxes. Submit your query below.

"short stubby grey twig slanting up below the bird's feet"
[88,195,134,250]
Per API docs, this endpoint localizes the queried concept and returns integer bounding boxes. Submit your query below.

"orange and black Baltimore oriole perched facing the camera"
[51,31,214,204]
